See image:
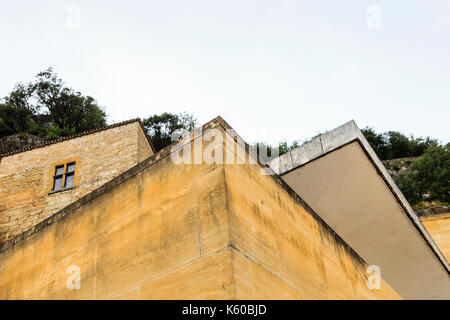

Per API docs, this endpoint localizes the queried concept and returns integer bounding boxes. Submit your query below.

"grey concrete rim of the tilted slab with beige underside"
[269,120,450,274]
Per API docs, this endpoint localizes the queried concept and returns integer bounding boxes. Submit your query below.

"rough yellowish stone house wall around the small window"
[0,121,153,244]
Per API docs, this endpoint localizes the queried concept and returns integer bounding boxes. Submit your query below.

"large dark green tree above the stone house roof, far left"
[0,68,106,138]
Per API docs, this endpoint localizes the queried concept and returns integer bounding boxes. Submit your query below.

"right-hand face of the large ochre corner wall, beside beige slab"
[225,142,400,299]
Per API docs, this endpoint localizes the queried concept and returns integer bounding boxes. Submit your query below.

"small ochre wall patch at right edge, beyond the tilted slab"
[420,212,450,262]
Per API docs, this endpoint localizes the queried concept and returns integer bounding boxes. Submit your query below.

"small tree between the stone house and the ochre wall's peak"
[143,112,197,151]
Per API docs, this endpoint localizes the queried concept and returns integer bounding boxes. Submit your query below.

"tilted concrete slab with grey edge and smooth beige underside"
[270,121,450,299]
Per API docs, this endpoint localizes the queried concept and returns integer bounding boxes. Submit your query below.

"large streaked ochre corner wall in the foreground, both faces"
[0,118,400,299]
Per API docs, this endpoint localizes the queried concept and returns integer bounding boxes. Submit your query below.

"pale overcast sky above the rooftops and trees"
[0,0,450,143]
